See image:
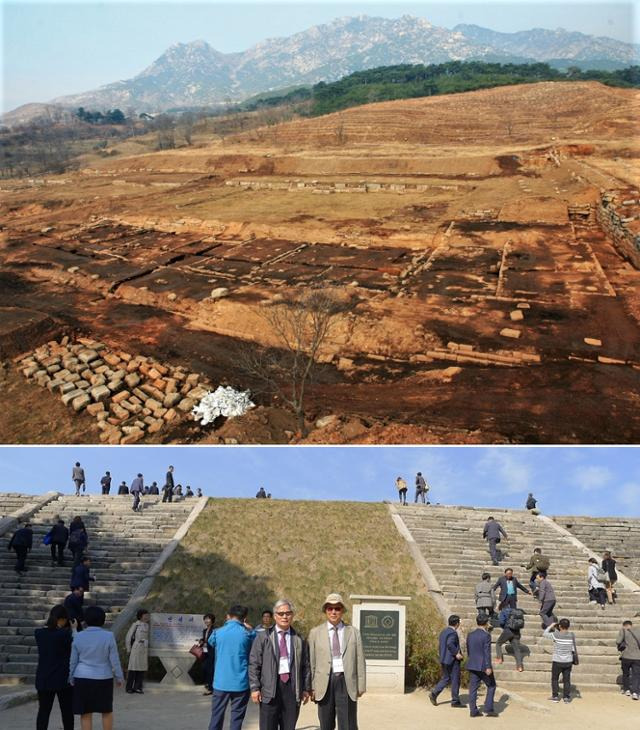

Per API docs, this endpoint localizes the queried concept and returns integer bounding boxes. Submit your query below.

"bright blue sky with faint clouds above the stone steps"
[0,446,640,516]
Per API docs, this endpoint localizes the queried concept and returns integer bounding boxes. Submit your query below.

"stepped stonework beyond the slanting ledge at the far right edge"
[553,516,640,584]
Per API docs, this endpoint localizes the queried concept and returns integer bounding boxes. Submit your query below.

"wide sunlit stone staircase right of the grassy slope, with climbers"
[397,505,640,689]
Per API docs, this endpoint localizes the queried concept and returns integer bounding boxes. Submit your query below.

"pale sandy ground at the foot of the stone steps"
[0,687,640,730]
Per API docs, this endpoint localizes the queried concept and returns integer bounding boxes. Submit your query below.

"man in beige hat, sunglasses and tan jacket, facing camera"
[309,593,367,730]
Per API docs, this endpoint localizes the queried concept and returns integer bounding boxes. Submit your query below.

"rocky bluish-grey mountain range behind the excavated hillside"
[4,15,640,123]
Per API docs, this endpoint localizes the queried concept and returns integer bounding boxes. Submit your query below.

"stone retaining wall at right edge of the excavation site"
[596,190,640,269]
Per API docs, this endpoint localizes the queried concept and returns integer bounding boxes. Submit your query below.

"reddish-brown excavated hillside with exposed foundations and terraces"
[0,82,640,444]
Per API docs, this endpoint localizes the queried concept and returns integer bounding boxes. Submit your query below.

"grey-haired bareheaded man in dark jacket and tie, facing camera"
[249,598,311,730]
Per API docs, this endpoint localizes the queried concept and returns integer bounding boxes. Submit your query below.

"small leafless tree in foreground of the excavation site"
[240,288,352,435]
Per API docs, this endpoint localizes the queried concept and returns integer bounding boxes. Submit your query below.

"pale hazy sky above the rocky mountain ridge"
[0,0,640,111]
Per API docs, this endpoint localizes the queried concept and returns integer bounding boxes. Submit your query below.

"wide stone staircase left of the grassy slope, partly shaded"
[0,495,196,683]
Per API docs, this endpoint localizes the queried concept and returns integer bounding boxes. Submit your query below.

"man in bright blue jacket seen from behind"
[209,605,256,730]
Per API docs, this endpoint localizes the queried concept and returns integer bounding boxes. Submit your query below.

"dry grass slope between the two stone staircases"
[146,499,443,685]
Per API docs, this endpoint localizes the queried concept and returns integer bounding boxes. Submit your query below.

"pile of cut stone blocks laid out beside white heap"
[17,337,211,444]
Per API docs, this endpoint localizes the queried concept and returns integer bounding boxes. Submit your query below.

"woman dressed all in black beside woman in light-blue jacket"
[35,605,73,730]
